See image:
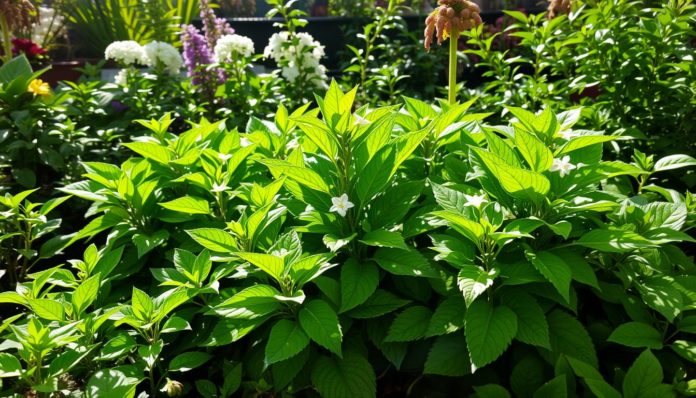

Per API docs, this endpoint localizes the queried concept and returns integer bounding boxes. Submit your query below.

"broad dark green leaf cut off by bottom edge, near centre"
[312,351,377,398]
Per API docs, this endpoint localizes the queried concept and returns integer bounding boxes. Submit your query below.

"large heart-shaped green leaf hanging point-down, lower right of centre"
[464,299,517,370]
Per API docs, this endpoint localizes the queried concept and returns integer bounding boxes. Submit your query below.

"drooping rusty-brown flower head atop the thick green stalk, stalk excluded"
[425,0,483,50]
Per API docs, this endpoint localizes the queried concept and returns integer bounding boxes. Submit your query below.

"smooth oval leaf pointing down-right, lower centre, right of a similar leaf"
[299,300,343,356]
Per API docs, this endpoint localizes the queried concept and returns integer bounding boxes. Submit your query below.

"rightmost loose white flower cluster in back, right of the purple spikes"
[263,32,326,87]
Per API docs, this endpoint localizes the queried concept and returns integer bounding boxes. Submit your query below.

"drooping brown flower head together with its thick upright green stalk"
[425,0,482,104]
